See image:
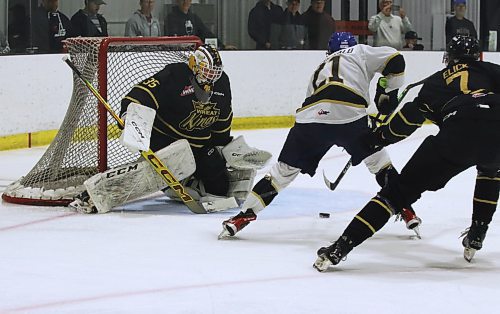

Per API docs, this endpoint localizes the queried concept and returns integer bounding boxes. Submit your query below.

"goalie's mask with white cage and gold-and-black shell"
[188,45,222,92]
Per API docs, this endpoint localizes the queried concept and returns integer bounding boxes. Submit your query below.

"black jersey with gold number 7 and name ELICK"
[383,61,500,143]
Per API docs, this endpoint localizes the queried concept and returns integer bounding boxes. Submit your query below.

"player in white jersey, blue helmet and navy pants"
[219,33,414,238]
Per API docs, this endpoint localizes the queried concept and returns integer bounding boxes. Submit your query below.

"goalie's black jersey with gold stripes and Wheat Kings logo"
[121,63,233,150]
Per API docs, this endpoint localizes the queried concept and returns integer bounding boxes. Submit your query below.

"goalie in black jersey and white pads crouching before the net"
[70,45,271,213]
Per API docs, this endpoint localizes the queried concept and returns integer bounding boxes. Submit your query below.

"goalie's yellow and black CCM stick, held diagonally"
[63,56,208,214]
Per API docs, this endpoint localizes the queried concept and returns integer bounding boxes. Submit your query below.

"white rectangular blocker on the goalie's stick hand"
[120,103,156,153]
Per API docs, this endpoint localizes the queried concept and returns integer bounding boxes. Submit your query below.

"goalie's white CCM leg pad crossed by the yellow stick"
[84,140,196,213]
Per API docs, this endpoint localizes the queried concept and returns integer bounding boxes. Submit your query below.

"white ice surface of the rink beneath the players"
[0,126,500,314]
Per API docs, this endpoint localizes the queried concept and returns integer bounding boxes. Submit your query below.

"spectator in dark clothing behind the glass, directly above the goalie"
[165,0,236,50]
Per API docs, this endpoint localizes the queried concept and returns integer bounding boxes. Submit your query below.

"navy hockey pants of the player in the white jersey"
[278,117,377,177]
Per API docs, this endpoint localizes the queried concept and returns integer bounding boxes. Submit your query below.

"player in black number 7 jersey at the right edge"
[314,36,500,271]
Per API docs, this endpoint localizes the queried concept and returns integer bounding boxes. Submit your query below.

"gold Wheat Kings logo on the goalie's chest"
[179,100,220,131]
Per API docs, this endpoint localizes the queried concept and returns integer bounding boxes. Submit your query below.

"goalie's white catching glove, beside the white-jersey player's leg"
[222,135,272,169]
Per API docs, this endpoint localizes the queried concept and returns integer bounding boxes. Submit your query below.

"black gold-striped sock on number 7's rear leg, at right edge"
[472,173,500,224]
